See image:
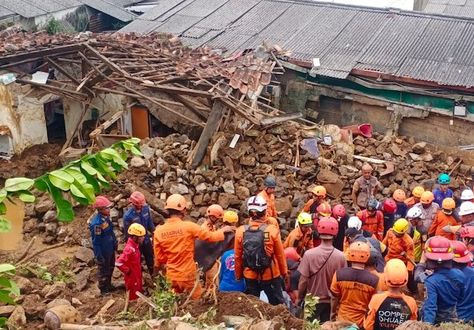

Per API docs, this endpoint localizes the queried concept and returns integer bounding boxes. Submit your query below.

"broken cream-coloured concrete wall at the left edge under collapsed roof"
[0,84,49,153]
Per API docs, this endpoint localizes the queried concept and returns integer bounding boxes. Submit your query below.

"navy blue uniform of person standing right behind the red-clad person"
[123,205,155,274]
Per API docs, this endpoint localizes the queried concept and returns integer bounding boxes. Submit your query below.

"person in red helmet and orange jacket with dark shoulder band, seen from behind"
[331,242,379,328]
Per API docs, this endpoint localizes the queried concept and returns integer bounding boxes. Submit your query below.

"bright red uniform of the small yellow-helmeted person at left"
[115,238,143,300]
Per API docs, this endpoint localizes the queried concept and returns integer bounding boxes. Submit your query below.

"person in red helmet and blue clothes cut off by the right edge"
[451,241,474,322]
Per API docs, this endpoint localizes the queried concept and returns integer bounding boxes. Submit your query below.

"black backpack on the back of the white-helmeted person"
[242,224,272,274]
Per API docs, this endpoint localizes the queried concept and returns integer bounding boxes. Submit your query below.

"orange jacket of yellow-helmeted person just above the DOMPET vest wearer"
[382,228,415,271]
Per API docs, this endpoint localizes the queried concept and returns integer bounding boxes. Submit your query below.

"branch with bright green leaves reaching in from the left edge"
[0,138,142,232]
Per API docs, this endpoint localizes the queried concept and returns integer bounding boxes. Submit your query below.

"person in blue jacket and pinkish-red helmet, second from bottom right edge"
[415,236,466,324]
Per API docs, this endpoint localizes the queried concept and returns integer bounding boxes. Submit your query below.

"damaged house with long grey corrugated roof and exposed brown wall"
[122,0,474,146]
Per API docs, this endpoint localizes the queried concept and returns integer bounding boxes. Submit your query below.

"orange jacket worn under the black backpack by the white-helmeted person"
[234,220,288,281]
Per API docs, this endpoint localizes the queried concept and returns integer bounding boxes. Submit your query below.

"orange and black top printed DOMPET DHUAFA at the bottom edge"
[364,292,418,330]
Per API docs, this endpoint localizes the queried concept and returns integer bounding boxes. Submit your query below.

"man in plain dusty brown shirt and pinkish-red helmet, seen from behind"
[296,218,346,323]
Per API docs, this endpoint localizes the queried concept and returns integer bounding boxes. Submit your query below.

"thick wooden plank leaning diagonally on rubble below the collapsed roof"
[191,100,225,168]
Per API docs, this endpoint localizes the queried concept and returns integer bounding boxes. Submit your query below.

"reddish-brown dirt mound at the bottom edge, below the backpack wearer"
[182,292,303,329]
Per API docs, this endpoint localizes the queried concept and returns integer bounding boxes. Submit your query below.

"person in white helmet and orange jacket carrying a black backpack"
[234,196,288,305]
